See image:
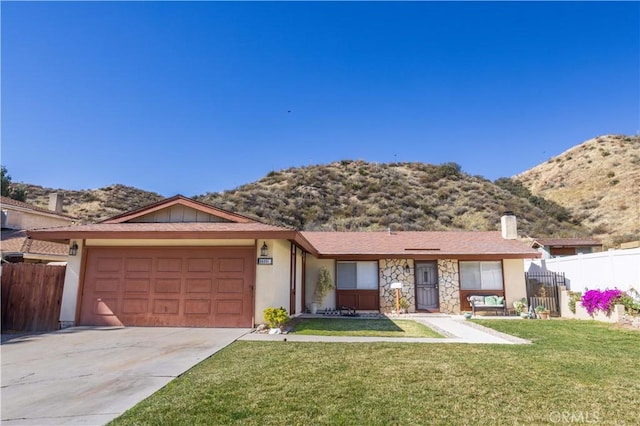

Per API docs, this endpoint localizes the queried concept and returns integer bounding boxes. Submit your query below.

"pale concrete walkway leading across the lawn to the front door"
[238,314,531,345]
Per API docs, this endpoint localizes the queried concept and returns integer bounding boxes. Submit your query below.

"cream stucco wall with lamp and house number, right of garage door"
[255,240,291,324]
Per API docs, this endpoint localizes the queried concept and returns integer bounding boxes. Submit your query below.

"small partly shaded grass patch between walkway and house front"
[292,318,443,337]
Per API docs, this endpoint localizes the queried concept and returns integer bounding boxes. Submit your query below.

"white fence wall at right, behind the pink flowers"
[524,248,640,291]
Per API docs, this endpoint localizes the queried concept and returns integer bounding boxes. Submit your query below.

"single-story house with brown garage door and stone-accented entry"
[29,195,540,327]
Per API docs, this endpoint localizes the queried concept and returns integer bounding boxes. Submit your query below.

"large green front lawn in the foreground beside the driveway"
[113,320,640,425]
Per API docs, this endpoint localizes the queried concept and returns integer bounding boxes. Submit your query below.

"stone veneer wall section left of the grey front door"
[378,259,416,313]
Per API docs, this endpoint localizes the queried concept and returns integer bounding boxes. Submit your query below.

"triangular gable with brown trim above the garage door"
[101,195,257,223]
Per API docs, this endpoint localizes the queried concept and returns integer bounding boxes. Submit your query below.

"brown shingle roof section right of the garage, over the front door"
[302,231,539,259]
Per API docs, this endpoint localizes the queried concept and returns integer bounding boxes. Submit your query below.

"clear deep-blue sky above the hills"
[0,1,640,196]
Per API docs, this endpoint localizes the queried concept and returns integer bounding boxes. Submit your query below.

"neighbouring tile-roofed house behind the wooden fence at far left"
[0,194,76,263]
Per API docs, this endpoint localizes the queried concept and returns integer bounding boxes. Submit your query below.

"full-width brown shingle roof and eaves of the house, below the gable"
[29,222,540,258]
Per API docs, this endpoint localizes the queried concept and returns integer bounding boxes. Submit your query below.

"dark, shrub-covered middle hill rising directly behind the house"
[192,160,588,236]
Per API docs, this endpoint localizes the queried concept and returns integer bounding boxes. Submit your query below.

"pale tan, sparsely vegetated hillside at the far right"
[514,135,640,245]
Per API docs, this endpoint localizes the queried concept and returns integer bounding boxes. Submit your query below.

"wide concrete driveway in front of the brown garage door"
[1,327,249,425]
